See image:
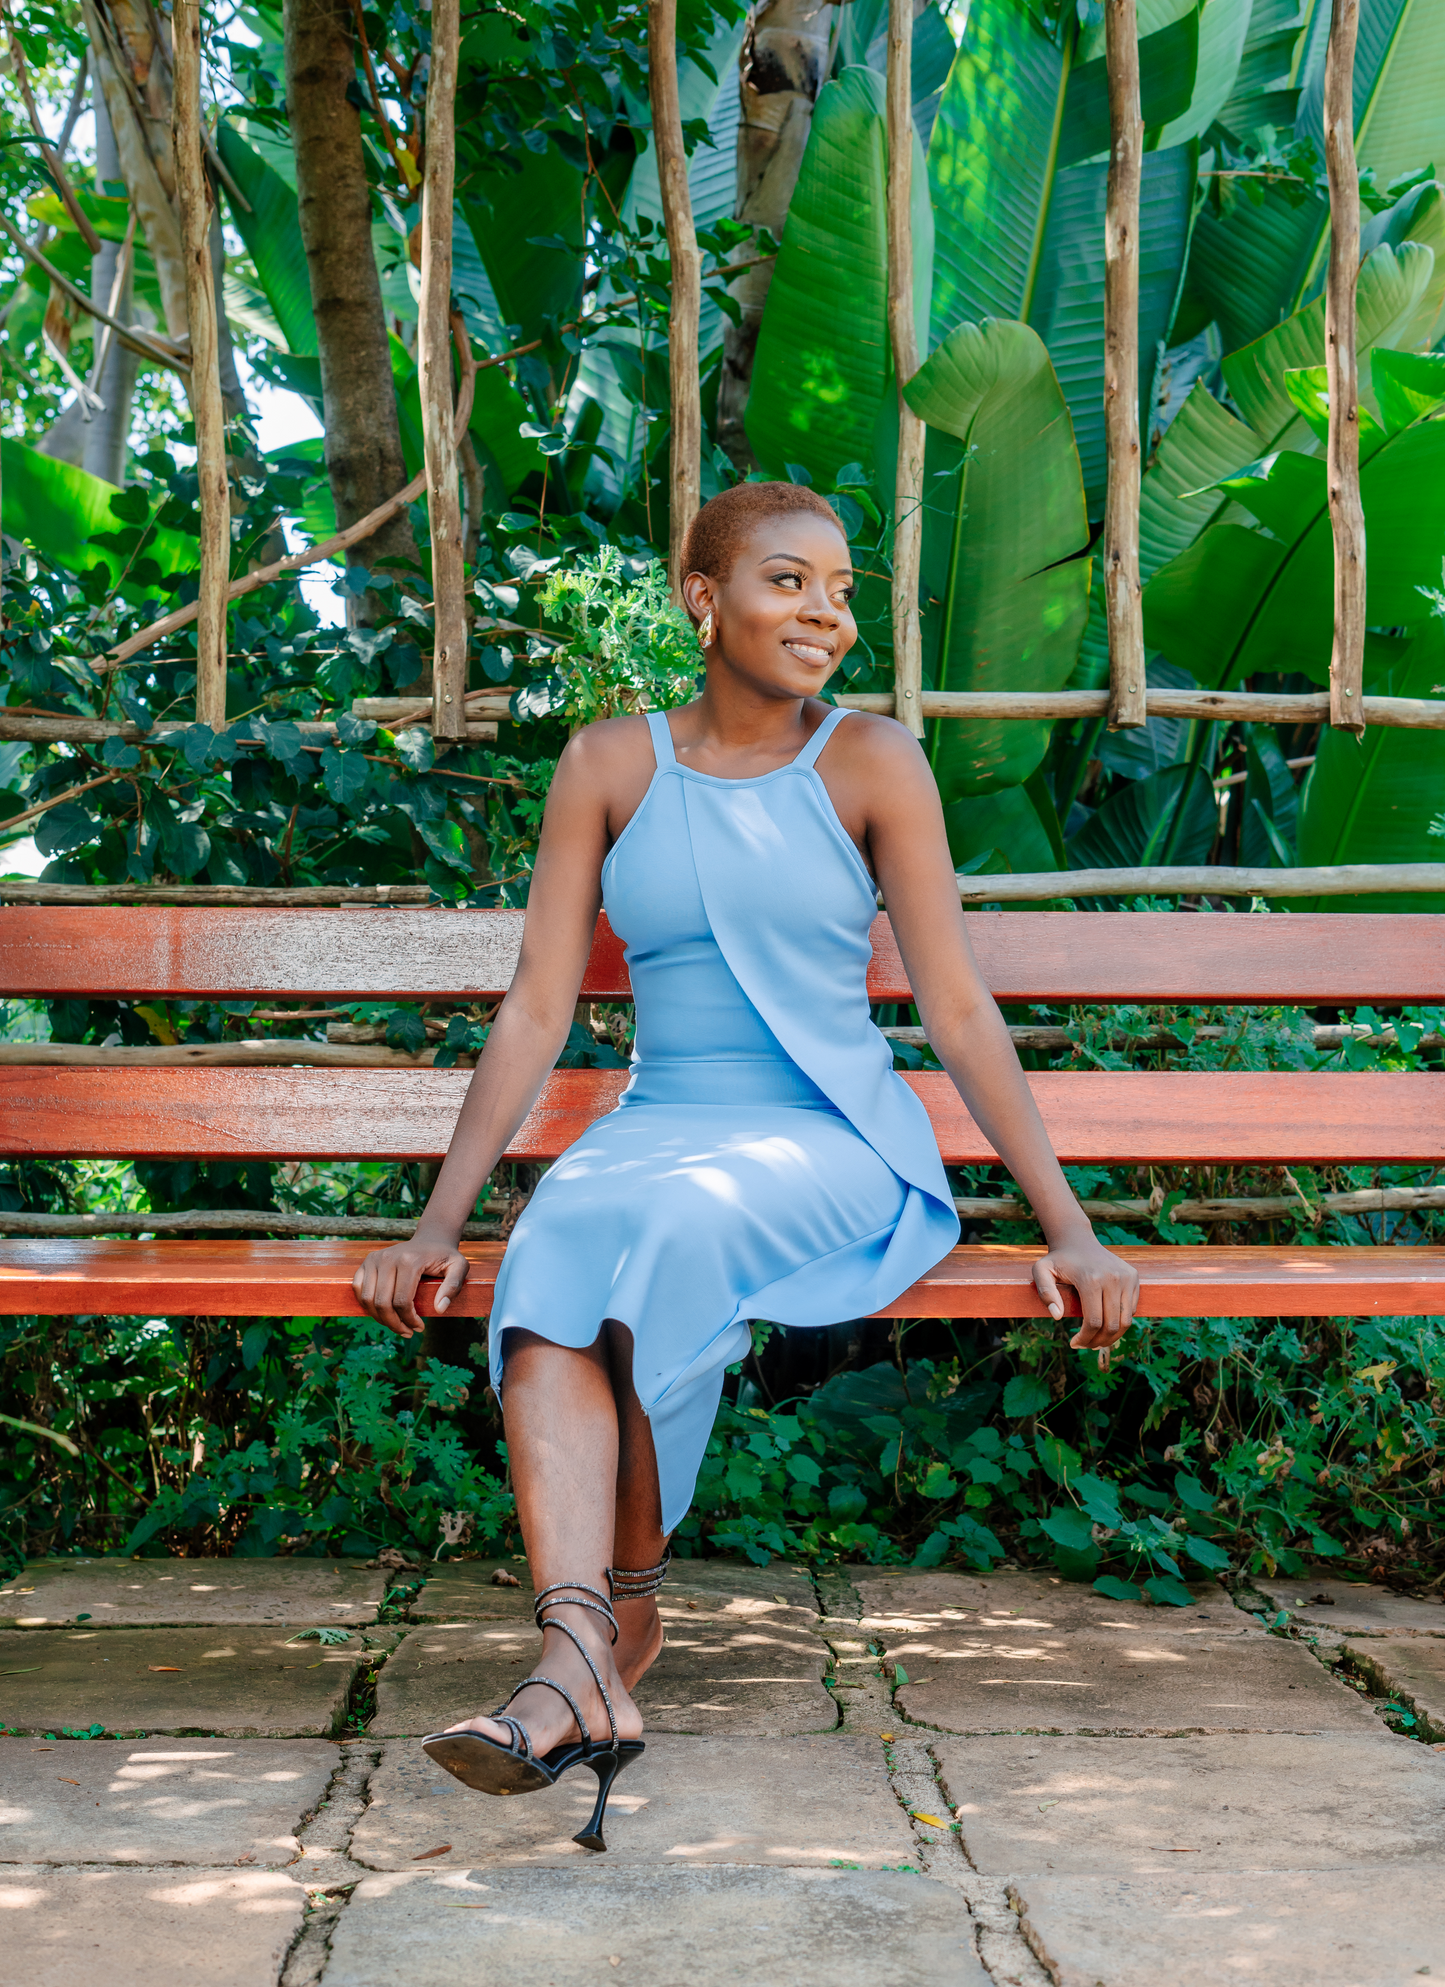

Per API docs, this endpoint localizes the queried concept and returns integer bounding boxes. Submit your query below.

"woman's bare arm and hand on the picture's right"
[839,723,1139,1347]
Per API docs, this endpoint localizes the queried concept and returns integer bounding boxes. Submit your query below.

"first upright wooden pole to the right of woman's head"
[886,0,924,737]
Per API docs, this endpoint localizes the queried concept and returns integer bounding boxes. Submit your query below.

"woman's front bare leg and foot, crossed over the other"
[449,1331,652,1753]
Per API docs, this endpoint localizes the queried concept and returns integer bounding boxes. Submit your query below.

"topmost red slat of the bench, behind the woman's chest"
[0,914,1445,1005]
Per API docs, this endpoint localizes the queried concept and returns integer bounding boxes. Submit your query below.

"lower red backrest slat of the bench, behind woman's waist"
[0,1067,1445,1164]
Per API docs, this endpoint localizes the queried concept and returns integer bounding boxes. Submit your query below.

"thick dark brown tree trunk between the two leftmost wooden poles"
[284,0,415,566]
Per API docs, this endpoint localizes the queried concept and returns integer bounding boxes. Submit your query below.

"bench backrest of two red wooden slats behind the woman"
[0,906,1445,1164]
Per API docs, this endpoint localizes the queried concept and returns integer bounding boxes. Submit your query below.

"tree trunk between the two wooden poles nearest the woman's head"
[718,0,837,471]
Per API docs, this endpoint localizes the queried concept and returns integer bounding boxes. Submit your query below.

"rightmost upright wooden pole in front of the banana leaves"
[1324,0,1365,733]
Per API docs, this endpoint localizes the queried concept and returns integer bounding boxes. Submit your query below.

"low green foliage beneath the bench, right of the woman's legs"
[682,1317,1445,1605]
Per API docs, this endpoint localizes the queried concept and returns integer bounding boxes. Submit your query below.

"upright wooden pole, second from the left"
[419,0,467,739]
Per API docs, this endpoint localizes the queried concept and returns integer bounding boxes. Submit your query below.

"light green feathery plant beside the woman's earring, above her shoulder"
[532,544,702,729]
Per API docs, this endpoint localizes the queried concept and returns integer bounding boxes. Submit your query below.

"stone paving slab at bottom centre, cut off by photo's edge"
[321,1859,989,1987]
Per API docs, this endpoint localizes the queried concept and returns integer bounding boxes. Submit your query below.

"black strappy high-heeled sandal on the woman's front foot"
[421,1574,646,1850]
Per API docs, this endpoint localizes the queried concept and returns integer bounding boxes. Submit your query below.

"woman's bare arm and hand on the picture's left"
[352,725,640,1335]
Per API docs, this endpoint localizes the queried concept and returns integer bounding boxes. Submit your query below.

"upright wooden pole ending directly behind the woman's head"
[648,0,702,600]
